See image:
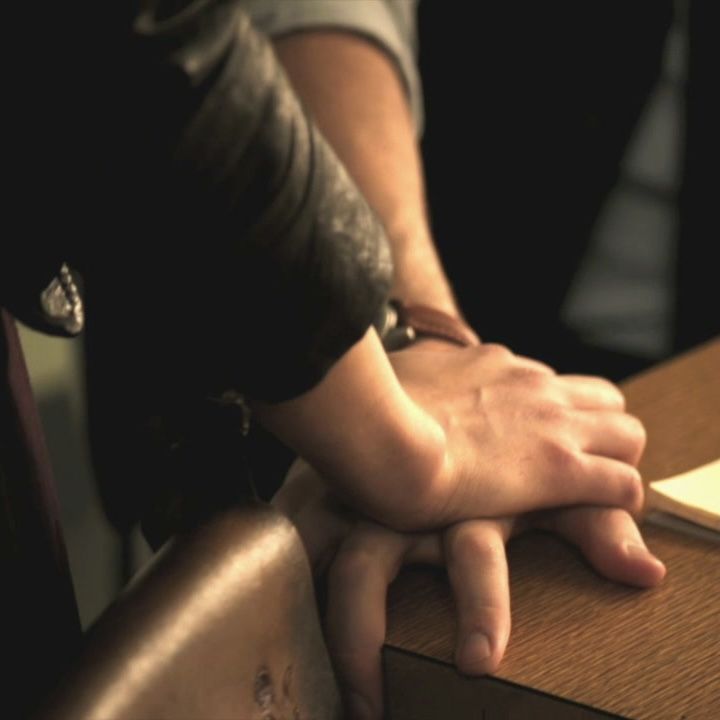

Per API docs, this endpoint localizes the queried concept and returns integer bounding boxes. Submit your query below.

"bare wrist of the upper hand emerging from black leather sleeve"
[254,329,447,529]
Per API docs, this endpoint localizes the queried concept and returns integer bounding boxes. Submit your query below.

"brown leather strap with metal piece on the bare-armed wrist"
[375,300,480,352]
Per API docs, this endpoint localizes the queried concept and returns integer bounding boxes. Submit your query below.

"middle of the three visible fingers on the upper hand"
[576,411,647,465]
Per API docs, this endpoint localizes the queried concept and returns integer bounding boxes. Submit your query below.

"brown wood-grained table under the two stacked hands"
[384,338,720,720]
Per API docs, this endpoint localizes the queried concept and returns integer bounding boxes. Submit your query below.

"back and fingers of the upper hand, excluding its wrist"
[390,343,645,527]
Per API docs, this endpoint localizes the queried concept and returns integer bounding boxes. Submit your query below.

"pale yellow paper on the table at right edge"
[648,459,720,532]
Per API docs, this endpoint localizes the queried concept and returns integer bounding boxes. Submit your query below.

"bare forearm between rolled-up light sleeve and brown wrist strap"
[275,30,458,314]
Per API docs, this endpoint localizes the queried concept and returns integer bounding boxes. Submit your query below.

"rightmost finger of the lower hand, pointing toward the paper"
[537,507,666,587]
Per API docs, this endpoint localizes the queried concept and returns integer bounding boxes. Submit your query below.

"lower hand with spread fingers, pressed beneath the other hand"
[273,461,665,720]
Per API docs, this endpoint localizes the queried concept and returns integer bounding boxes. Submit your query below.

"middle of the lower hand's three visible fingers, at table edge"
[444,520,511,675]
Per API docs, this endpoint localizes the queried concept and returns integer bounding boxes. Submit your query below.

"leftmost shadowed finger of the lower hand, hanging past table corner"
[326,523,408,720]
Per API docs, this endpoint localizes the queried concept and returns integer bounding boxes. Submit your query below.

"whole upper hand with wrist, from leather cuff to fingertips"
[255,330,645,531]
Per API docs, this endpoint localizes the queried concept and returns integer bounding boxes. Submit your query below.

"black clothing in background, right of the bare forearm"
[419,0,680,380]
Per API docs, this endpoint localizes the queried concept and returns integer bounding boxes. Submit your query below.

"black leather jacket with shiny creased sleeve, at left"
[0,0,391,717]
